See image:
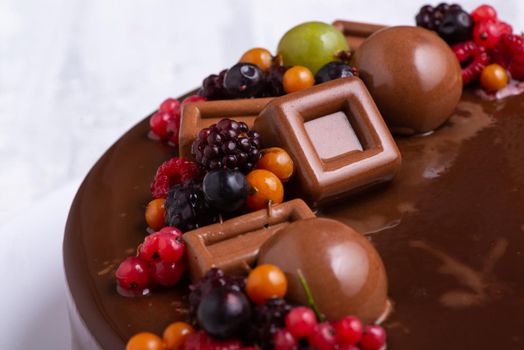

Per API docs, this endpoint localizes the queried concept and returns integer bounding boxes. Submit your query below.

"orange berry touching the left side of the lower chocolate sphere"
[246,264,287,304]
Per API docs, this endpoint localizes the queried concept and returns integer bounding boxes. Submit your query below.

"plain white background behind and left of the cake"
[0,0,524,350]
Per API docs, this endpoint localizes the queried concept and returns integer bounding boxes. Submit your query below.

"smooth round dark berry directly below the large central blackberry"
[203,169,247,212]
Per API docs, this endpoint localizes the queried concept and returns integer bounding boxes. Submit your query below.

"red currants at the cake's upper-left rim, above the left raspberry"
[149,95,206,146]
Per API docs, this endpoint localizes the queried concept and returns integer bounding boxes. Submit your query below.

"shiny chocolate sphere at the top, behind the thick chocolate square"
[353,26,462,134]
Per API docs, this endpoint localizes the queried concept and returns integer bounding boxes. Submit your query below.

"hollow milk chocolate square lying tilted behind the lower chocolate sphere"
[183,199,315,281]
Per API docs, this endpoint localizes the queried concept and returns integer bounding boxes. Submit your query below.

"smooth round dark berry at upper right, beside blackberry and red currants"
[437,9,473,45]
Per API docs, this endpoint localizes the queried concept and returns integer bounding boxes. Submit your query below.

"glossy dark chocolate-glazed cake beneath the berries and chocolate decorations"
[64,21,524,350]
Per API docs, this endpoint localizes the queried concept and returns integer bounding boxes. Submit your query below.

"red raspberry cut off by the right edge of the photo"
[492,34,524,80]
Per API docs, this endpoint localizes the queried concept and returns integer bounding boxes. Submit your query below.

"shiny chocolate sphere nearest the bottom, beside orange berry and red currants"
[258,218,389,323]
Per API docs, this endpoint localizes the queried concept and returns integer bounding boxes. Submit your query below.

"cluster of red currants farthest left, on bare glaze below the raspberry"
[116,227,186,296]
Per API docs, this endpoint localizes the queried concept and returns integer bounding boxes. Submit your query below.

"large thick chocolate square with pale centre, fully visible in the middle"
[254,77,401,204]
